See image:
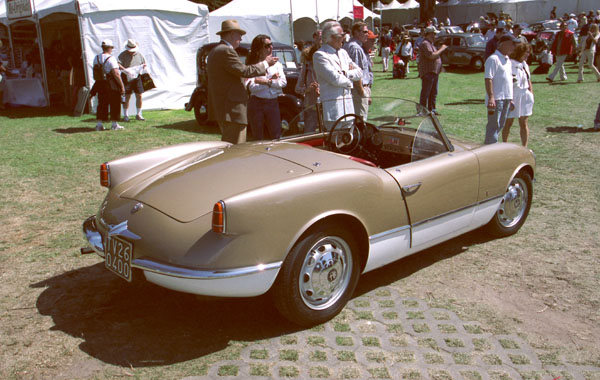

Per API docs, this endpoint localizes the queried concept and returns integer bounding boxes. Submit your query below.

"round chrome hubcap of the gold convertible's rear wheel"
[298,236,352,310]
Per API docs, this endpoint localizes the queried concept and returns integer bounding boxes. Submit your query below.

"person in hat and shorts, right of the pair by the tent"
[118,38,146,122]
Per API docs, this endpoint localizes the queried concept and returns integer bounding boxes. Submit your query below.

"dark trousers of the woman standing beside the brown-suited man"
[248,96,281,140]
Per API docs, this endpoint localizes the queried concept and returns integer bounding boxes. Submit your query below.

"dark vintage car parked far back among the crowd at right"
[435,33,485,71]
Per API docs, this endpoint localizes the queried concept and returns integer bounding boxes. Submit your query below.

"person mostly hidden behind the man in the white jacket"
[294,31,321,133]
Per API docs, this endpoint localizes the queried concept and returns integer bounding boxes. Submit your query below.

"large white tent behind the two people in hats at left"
[0,0,208,109]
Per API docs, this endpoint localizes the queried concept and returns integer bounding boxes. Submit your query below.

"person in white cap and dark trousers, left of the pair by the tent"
[92,39,125,131]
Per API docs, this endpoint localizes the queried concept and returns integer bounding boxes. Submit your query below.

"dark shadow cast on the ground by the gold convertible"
[30,227,488,368]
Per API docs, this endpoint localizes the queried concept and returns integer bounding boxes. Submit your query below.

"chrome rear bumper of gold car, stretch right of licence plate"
[131,259,283,280]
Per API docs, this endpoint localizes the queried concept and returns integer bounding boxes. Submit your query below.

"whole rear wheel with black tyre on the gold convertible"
[273,225,360,326]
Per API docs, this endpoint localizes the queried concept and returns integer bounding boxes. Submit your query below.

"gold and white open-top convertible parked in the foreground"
[82,98,535,326]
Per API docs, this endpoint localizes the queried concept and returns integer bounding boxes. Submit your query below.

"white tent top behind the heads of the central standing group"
[209,0,379,44]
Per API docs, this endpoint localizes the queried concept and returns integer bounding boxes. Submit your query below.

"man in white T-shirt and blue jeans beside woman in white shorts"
[484,33,519,144]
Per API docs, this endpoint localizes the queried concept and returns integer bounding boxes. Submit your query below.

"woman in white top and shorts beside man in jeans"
[502,43,534,146]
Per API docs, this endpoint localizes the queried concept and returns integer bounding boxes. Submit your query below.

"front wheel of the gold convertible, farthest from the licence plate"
[486,171,533,237]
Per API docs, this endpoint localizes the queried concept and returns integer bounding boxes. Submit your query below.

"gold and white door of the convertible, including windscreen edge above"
[386,118,479,250]
